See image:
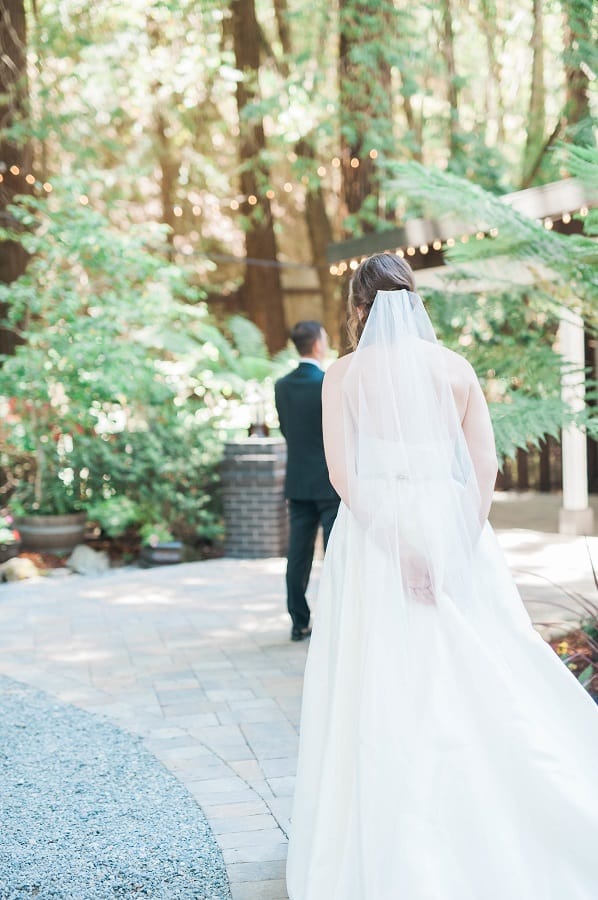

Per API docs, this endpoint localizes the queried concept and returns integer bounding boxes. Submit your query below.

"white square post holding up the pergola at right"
[559,308,594,534]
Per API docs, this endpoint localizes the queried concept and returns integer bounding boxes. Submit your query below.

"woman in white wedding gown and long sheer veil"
[287,254,598,900]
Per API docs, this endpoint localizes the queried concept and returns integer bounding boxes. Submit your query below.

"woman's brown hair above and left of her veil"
[347,253,415,350]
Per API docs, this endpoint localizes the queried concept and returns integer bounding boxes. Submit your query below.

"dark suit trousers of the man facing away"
[287,498,339,628]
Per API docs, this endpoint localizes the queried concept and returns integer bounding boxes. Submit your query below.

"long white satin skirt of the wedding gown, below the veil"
[287,504,598,900]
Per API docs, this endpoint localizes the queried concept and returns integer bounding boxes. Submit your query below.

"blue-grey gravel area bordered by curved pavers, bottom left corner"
[0,677,230,900]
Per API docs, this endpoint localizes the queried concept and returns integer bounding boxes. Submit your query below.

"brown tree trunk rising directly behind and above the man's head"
[231,0,287,352]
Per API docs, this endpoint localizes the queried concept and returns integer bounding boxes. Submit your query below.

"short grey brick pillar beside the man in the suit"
[221,437,287,559]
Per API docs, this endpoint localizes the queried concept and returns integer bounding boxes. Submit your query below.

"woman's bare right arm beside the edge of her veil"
[462,369,498,523]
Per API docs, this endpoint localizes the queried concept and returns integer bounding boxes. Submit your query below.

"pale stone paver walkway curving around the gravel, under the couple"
[0,498,598,900]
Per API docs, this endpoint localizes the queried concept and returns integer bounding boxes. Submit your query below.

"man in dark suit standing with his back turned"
[274,322,340,641]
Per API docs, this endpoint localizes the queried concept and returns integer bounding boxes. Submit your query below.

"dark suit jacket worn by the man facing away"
[274,362,337,500]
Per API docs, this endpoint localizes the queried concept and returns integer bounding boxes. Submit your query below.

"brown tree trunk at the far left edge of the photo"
[0,0,31,353]
